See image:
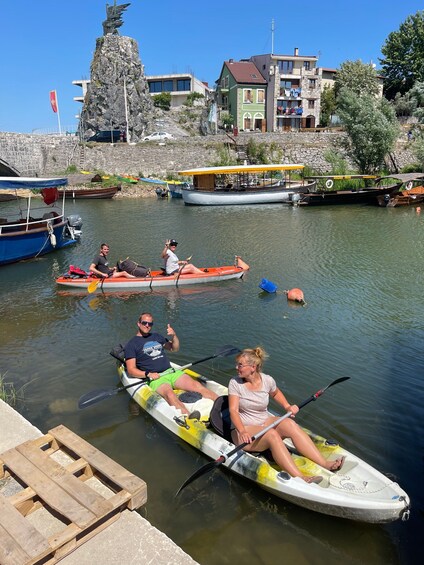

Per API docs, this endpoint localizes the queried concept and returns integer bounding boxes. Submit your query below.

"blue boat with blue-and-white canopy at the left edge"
[0,177,82,265]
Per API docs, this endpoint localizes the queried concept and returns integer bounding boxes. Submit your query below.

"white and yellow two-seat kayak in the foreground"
[111,361,410,523]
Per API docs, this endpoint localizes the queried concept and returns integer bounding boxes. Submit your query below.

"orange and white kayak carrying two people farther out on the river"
[56,257,249,291]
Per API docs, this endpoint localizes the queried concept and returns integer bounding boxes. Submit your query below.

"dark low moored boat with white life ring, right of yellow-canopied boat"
[296,175,402,206]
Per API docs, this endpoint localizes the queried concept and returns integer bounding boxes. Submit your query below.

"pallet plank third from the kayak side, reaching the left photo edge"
[2,449,96,527]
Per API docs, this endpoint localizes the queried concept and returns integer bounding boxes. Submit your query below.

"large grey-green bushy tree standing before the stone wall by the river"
[337,88,399,174]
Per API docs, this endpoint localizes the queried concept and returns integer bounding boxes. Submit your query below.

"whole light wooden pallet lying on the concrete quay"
[0,426,147,565]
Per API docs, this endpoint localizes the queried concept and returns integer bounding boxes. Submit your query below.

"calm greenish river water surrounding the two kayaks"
[0,198,424,565]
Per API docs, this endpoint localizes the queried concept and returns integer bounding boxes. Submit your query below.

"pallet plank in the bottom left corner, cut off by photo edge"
[0,494,50,564]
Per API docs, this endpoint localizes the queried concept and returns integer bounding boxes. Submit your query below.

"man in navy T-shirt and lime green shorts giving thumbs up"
[121,312,217,418]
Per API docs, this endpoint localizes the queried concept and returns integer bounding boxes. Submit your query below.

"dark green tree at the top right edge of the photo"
[380,11,424,100]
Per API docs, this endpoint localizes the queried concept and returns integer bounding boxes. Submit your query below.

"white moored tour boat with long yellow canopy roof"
[178,164,315,206]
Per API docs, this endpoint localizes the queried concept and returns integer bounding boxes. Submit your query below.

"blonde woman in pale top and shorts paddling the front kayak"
[228,347,344,483]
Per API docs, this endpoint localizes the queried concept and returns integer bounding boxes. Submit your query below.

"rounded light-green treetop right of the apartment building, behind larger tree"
[334,60,379,98]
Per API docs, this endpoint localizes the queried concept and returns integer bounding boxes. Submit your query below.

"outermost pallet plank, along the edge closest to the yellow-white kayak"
[49,425,147,507]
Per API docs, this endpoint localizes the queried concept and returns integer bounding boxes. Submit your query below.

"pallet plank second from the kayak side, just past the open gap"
[16,441,113,518]
